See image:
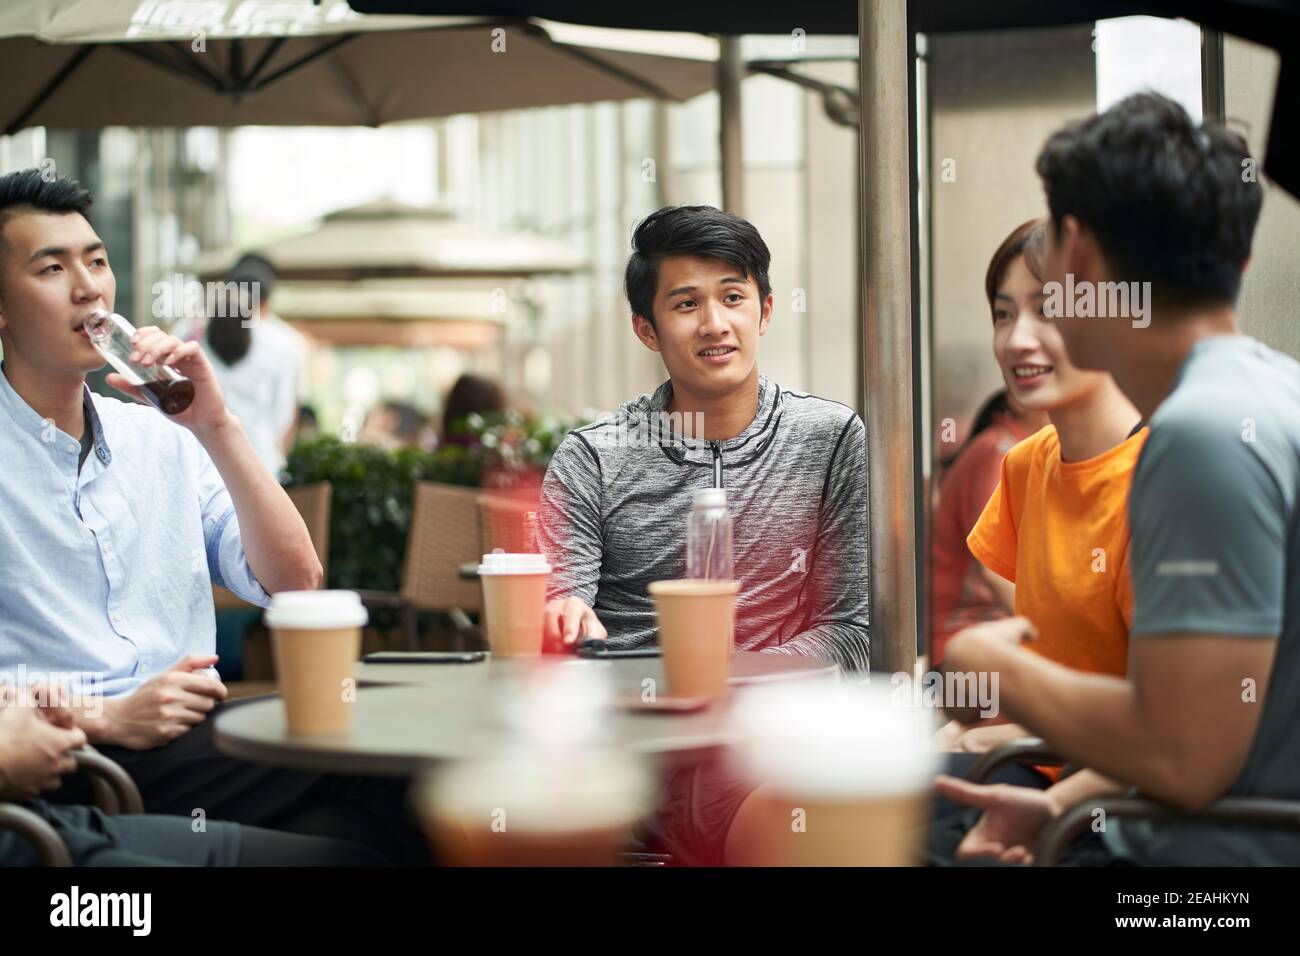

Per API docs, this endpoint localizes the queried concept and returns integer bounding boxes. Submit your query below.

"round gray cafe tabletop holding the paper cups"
[213,652,839,777]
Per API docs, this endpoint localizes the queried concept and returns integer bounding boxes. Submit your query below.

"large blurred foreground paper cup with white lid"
[728,679,940,866]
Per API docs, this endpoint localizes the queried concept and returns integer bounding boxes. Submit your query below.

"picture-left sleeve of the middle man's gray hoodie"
[537,433,605,607]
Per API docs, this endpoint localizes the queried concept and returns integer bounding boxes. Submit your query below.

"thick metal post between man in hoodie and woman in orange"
[858,0,917,674]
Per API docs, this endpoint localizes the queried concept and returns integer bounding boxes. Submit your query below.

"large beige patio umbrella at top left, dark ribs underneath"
[0,0,718,134]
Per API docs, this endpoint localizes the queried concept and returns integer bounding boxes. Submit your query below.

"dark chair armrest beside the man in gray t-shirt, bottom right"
[1034,796,1300,866]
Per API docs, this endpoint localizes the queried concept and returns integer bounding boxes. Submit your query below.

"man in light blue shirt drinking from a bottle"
[0,169,426,861]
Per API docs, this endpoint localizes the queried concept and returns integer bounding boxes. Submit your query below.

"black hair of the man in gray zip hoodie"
[623,206,772,325]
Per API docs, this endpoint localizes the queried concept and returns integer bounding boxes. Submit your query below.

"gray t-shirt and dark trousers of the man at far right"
[1108,336,1300,864]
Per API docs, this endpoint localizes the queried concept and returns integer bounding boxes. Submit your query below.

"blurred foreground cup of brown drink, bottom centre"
[416,748,651,866]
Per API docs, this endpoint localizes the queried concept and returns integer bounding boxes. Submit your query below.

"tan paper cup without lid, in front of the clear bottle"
[649,579,740,698]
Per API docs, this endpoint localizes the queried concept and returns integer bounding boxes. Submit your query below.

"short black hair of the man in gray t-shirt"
[1037,92,1262,308]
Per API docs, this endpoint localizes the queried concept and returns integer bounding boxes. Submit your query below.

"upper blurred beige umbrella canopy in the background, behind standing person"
[192,199,584,282]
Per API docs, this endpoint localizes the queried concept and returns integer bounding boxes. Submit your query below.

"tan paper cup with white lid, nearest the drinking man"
[264,591,368,734]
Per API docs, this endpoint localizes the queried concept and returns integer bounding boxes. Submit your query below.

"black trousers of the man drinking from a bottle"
[47,701,430,865]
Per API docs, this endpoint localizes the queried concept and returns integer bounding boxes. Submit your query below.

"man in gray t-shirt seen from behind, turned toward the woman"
[945,94,1300,864]
